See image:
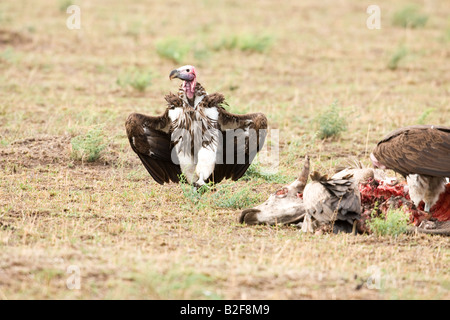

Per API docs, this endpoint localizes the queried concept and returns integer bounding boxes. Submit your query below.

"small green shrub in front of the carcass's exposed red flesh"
[367,209,409,236]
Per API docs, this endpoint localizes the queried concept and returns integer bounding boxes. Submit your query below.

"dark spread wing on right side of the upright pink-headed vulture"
[205,93,267,183]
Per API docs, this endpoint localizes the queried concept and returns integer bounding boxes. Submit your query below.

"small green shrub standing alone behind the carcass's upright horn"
[314,101,347,139]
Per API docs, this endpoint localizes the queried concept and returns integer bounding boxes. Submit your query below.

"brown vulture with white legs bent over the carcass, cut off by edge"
[370,125,450,212]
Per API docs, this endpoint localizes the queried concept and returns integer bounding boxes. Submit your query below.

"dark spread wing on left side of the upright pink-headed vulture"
[125,94,182,184]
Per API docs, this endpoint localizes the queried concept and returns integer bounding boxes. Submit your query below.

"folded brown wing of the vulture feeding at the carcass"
[373,125,450,177]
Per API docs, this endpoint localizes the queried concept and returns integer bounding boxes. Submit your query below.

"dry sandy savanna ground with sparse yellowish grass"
[0,0,450,299]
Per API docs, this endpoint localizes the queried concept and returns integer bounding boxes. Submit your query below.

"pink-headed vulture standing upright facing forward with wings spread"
[125,65,267,187]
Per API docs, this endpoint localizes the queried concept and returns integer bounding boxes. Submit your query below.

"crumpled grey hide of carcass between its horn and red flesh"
[303,172,361,232]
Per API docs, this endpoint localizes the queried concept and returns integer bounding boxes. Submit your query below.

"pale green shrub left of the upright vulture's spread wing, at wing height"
[70,126,106,162]
